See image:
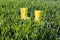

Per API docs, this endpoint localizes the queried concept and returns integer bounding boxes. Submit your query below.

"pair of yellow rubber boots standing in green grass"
[20,8,42,21]
